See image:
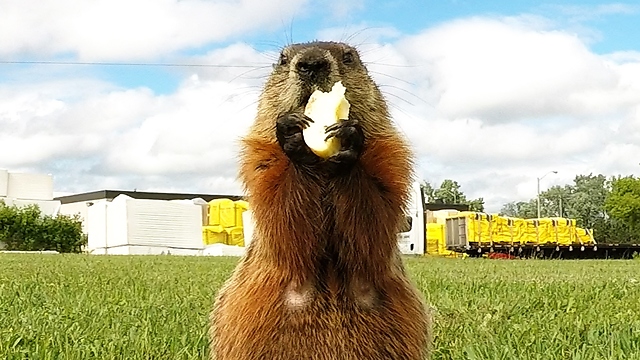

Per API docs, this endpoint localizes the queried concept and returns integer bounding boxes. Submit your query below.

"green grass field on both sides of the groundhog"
[0,254,640,360]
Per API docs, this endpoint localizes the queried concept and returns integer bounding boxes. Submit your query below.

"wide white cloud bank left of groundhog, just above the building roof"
[0,45,262,193]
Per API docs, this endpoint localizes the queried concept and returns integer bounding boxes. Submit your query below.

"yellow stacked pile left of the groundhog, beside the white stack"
[202,199,249,246]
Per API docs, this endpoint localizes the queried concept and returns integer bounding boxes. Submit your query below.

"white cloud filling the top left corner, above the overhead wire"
[0,0,307,60]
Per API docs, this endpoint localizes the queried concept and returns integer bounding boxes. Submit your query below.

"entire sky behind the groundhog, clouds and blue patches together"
[0,0,640,211]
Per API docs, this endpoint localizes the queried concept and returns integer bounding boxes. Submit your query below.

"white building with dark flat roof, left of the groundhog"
[56,190,241,255]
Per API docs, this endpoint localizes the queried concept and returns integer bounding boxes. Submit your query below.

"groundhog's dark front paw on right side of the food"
[326,119,364,170]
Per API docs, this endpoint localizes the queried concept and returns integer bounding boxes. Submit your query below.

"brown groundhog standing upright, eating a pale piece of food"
[210,42,431,360]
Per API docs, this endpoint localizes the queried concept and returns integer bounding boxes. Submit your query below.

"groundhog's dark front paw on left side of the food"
[276,113,320,164]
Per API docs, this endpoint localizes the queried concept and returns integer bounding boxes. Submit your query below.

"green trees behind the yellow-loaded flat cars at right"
[422,174,640,243]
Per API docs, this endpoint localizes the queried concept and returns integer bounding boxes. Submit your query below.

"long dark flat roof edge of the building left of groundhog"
[54,190,244,204]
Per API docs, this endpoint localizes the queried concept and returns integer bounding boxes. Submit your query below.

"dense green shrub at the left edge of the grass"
[0,200,87,253]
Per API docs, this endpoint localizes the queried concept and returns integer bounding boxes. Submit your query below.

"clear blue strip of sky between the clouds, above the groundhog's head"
[10,0,640,94]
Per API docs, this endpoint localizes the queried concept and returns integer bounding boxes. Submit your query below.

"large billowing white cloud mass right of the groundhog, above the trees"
[356,17,640,211]
